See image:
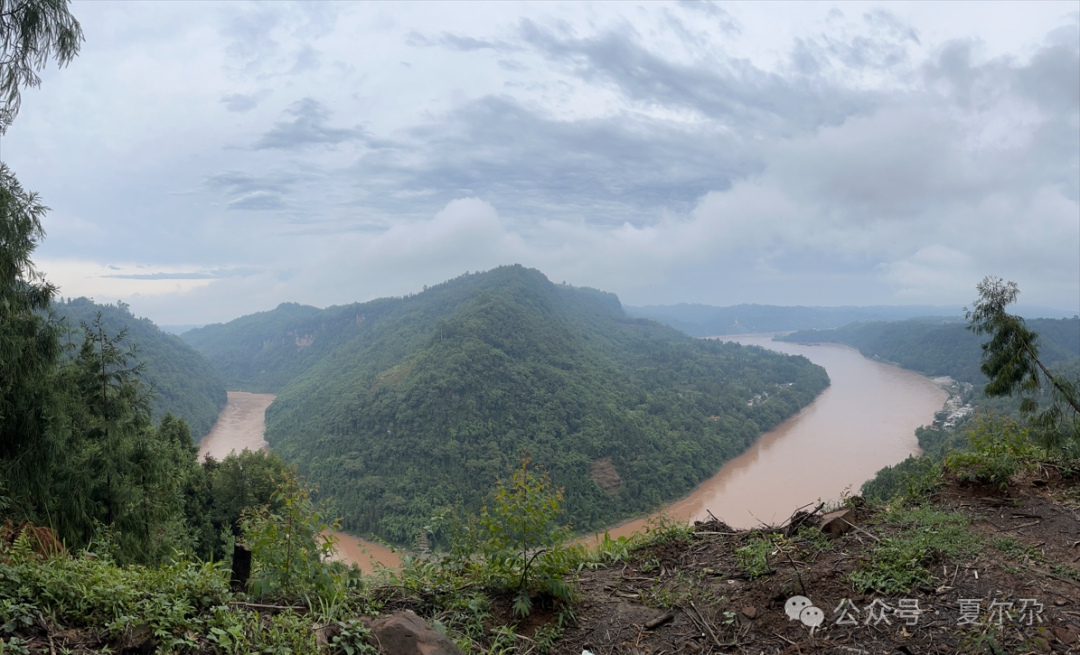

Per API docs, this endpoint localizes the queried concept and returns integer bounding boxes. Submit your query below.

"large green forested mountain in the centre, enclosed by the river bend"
[185,266,828,543]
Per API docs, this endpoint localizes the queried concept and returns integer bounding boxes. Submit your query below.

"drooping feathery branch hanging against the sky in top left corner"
[0,0,83,134]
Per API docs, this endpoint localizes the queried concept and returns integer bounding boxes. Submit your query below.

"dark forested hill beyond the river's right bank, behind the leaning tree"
[777,318,1080,386]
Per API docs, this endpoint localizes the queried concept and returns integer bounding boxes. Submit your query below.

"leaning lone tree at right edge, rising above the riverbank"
[964,276,1080,451]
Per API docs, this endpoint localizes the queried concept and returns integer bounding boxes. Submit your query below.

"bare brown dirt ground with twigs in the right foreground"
[552,469,1080,655]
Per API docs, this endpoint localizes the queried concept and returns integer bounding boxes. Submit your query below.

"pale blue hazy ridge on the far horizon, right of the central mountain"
[625,304,1072,336]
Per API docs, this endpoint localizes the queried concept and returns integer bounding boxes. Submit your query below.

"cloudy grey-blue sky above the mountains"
[0,0,1080,324]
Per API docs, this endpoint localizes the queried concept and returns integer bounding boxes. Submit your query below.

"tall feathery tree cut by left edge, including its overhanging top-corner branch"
[0,0,82,513]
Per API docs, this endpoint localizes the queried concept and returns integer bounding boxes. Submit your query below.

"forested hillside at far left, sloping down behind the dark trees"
[52,298,226,441]
